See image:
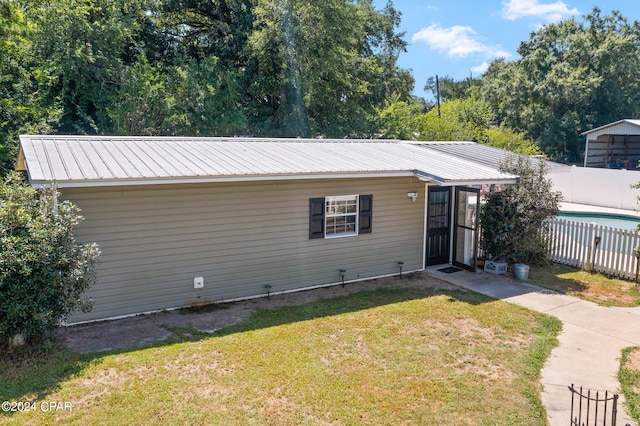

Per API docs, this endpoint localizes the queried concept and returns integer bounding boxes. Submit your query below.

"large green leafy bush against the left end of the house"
[0,172,99,345]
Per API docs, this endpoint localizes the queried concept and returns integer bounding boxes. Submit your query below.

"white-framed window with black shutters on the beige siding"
[309,195,373,238]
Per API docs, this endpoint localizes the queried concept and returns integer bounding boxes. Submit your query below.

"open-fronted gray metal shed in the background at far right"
[582,119,640,170]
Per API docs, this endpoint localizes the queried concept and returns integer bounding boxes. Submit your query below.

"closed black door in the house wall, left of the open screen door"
[425,186,451,266]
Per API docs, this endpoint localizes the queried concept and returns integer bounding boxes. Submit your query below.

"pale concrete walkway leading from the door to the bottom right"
[426,266,640,426]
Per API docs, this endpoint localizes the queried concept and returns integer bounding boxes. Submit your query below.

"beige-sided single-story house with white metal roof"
[16,135,516,323]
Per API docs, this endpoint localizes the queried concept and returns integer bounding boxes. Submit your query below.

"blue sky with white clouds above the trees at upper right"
[373,0,640,99]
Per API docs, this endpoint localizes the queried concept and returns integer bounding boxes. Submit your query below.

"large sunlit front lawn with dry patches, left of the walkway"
[0,288,561,425]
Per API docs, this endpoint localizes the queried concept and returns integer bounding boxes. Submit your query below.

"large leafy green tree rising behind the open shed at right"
[481,8,640,162]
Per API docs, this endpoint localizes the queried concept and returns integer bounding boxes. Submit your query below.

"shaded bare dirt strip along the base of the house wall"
[56,273,459,352]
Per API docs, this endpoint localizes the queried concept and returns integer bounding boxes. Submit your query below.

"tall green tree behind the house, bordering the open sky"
[245,0,413,137]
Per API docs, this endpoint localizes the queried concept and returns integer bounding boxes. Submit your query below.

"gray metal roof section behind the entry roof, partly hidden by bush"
[415,141,569,169]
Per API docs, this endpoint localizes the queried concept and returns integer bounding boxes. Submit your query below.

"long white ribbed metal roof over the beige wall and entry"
[16,135,515,187]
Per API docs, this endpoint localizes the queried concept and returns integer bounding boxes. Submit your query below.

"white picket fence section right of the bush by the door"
[548,218,640,279]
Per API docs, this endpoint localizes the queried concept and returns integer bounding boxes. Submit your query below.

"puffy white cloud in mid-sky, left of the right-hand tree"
[412,24,510,58]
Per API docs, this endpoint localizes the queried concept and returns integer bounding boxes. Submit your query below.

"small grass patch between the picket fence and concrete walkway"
[529,263,640,307]
